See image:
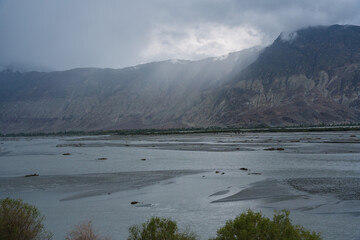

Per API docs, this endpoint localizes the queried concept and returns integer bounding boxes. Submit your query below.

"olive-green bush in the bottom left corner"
[0,198,52,240]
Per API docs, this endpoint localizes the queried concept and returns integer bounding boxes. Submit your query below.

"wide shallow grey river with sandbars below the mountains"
[0,132,360,240]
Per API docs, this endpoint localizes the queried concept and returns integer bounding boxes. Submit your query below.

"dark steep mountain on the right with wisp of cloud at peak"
[185,25,360,126]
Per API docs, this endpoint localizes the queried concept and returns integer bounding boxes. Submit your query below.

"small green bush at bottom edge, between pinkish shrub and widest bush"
[128,217,197,240]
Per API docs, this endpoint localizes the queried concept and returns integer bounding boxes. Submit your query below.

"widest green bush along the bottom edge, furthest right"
[213,210,321,240]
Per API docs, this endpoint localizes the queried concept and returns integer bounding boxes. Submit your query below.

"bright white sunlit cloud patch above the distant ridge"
[141,23,263,62]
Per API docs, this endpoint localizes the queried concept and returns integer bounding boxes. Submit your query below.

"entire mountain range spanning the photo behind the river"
[0,25,360,133]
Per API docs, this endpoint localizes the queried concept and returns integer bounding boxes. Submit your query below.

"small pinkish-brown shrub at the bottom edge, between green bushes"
[65,222,108,240]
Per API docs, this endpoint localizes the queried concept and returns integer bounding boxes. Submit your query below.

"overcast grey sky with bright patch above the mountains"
[0,0,360,70]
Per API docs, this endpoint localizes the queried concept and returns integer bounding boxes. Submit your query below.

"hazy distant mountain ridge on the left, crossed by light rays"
[0,47,261,133]
